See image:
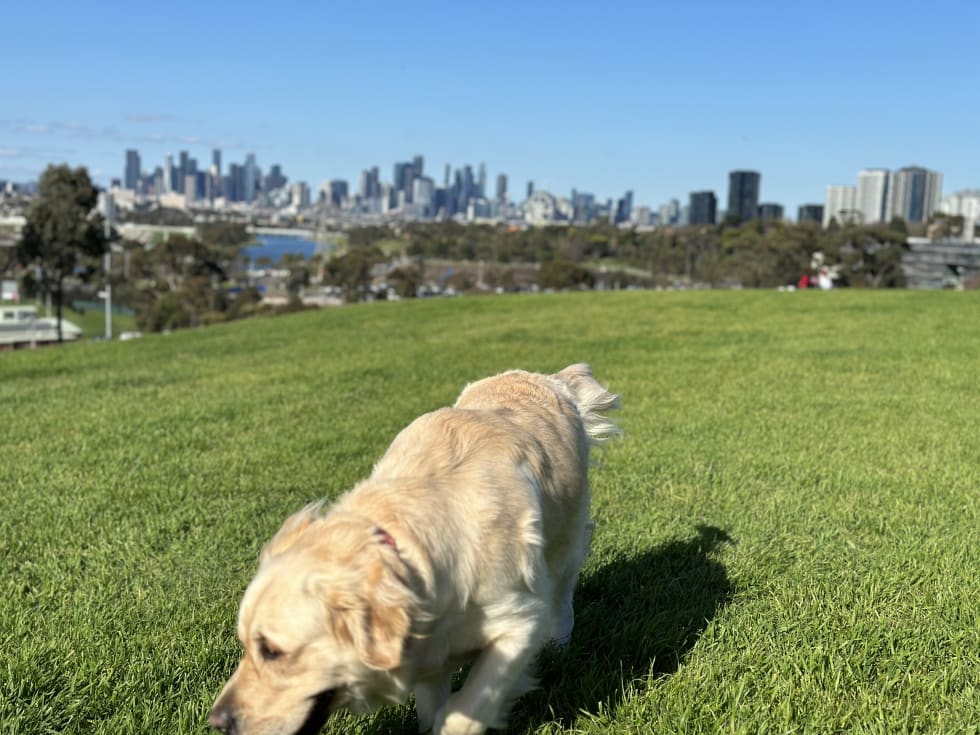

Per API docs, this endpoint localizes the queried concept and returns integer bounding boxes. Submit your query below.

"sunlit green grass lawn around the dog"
[0,291,980,734]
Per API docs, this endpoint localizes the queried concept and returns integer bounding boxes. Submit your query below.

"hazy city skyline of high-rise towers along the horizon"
[112,142,956,227]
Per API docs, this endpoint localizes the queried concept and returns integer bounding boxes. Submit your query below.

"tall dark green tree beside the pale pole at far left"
[17,164,106,342]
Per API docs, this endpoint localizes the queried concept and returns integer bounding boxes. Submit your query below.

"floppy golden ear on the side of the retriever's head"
[314,550,414,670]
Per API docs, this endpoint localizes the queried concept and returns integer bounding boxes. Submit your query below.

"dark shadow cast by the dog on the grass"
[508,526,734,732]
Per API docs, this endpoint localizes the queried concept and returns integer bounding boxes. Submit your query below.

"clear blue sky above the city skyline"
[0,0,980,214]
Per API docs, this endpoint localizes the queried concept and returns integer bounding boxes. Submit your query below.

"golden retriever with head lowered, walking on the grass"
[208,365,619,735]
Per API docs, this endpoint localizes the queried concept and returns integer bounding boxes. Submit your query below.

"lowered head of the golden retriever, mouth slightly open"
[208,507,415,735]
